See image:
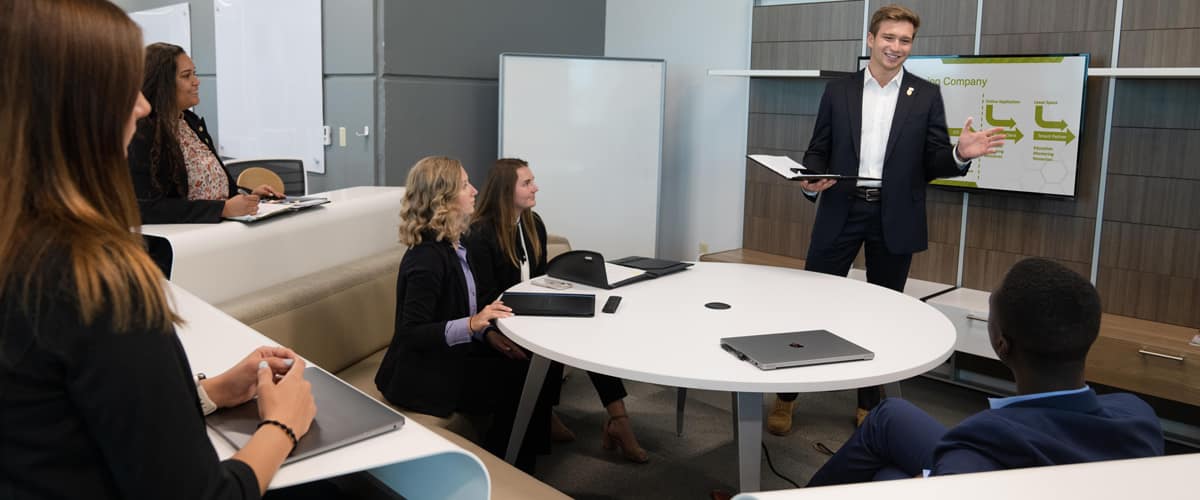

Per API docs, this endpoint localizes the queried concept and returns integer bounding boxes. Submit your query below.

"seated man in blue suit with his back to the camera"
[809,259,1164,487]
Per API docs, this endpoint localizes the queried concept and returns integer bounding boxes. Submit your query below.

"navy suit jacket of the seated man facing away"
[932,391,1163,475]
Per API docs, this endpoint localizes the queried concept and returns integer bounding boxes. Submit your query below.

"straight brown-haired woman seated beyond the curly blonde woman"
[466,158,648,463]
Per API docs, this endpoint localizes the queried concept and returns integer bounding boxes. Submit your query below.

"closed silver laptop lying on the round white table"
[721,330,875,369]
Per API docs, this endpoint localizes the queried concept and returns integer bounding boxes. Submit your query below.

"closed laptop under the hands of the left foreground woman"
[206,367,404,464]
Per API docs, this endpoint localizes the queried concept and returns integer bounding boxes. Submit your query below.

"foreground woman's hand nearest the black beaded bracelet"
[258,357,317,439]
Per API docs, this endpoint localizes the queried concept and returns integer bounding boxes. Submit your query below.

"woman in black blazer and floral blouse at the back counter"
[128,43,282,224]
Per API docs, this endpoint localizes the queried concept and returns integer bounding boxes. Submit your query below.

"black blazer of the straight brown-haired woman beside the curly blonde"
[463,212,546,307]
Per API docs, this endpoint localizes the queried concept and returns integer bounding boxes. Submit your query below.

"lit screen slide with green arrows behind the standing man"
[862,54,1088,197]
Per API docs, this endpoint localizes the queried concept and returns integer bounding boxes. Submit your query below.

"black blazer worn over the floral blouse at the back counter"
[128,110,238,224]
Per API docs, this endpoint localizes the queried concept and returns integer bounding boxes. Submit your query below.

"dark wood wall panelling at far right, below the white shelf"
[1097,74,1200,327]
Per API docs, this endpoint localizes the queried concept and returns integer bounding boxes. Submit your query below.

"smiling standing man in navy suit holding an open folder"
[767,5,1004,435]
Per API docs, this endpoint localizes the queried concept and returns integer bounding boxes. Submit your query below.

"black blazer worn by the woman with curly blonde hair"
[376,233,474,417]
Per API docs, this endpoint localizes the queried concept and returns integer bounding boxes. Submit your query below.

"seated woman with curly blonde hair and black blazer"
[376,157,550,470]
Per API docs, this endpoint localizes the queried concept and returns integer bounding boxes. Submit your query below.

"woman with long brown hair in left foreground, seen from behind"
[0,0,316,499]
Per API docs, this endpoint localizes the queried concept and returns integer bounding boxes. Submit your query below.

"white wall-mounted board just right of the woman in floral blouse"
[212,0,325,173]
